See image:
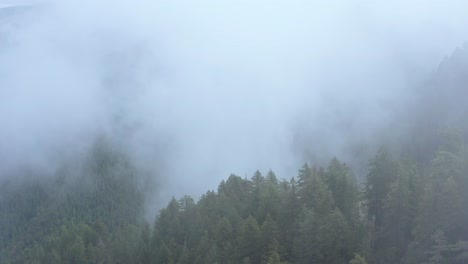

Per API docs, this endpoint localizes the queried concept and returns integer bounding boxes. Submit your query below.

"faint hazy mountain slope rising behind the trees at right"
[392,45,468,161]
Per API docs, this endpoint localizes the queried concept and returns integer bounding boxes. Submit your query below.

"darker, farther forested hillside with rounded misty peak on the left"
[0,140,148,264]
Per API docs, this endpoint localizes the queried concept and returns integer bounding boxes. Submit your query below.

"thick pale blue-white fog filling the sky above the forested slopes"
[0,0,468,205]
